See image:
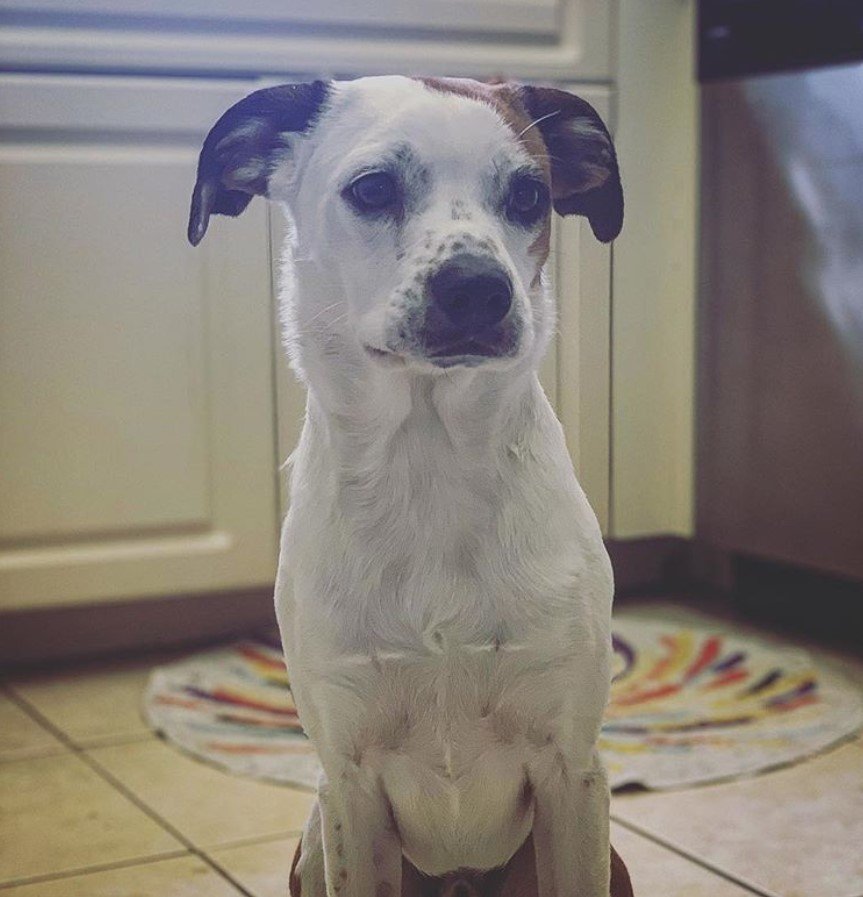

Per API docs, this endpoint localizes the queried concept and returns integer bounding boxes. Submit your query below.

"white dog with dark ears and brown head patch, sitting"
[188,76,629,897]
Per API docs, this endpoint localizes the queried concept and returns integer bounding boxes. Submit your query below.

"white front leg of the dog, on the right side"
[531,754,611,897]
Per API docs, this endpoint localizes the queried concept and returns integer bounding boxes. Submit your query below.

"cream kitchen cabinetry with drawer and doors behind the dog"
[6,0,708,609]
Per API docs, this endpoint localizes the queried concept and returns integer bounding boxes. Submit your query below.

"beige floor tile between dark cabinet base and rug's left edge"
[10,659,165,747]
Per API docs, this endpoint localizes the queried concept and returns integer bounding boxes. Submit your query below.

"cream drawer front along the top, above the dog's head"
[0,0,615,81]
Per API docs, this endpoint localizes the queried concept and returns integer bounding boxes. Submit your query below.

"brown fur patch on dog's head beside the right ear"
[419,78,551,272]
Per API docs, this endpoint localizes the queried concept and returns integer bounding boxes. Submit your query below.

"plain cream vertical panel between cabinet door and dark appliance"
[611,0,698,538]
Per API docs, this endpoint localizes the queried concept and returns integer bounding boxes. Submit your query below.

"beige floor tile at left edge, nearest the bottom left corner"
[0,754,181,881]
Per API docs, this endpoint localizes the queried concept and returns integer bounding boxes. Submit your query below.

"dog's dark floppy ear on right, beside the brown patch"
[522,86,623,243]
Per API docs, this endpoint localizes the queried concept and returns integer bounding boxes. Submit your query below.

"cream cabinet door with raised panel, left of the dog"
[0,75,277,610]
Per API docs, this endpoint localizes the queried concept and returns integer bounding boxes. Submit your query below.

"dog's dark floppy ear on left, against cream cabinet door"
[188,81,329,246]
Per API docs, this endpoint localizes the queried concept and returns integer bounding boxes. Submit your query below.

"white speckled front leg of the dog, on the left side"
[318,765,402,897]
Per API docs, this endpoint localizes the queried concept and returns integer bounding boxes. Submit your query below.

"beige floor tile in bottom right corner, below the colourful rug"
[612,744,863,897]
